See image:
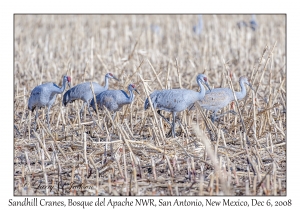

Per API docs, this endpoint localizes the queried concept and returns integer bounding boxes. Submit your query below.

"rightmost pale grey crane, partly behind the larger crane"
[199,76,253,122]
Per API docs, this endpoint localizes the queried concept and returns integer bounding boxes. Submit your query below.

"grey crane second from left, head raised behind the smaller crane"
[62,73,118,116]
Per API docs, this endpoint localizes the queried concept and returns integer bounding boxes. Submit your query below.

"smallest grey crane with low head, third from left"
[90,84,140,119]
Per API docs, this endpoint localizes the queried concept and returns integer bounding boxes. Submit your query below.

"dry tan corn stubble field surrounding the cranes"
[14,15,287,196]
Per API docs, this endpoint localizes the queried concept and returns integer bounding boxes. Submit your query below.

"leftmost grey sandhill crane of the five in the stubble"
[28,76,71,129]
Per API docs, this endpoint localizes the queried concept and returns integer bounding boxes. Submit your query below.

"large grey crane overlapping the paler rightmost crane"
[144,74,210,137]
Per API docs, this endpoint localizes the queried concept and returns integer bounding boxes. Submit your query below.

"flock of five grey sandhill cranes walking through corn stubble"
[28,73,253,137]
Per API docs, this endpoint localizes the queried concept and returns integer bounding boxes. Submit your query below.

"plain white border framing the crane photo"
[0,0,300,209]
